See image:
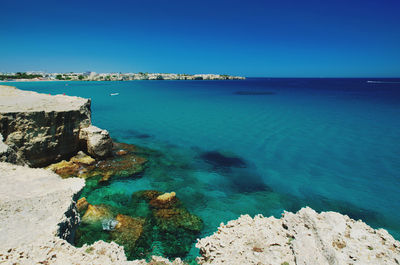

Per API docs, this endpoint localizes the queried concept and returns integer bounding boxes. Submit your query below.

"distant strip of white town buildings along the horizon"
[0,72,245,81]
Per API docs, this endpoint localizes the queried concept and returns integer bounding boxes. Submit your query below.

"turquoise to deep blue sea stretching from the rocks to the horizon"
[8,78,400,255]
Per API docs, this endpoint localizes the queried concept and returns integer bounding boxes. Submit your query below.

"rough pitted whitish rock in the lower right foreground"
[196,208,400,265]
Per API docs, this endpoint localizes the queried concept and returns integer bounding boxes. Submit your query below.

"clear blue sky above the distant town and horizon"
[0,0,400,77]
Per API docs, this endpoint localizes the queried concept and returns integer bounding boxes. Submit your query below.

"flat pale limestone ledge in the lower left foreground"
[0,162,184,265]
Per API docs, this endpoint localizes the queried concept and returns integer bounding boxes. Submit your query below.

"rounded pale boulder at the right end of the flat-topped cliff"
[79,125,113,158]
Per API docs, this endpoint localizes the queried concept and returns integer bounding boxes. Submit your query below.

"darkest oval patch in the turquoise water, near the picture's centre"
[200,151,247,168]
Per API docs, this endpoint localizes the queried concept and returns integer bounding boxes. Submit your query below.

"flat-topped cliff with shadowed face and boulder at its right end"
[0,86,112,167]
